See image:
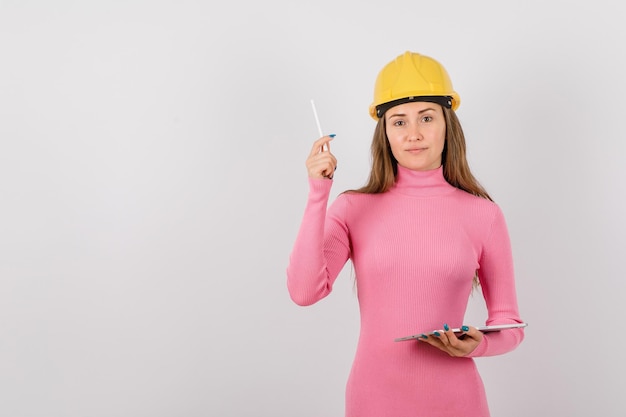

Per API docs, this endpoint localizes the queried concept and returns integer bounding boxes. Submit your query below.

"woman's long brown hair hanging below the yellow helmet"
[348,107,493,201]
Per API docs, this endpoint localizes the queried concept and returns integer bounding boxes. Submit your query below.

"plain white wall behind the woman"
[0,0,626,417]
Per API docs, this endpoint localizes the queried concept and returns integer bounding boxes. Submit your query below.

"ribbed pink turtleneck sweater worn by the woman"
[287,167,524,417]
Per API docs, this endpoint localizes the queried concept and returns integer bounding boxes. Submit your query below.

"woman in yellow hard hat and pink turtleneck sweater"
[287,52,524,417]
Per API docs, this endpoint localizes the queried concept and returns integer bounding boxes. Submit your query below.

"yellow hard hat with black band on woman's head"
[369,51,461,120]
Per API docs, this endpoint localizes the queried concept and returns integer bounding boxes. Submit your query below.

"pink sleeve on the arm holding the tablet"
[469,208,524,357]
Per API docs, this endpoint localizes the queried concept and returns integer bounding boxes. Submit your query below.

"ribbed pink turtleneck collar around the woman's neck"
[390,165,456,197]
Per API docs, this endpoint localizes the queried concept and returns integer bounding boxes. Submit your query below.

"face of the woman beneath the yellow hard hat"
[385,101,446,171]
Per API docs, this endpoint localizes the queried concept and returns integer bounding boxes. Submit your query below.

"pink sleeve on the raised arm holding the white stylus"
[287,179,350,306]
